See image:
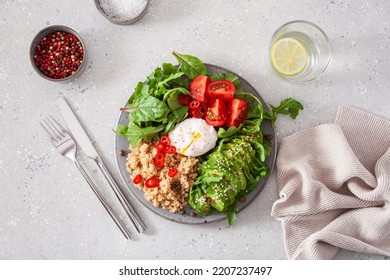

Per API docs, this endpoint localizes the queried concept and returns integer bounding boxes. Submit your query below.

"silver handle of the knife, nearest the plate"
[96,159,146,233]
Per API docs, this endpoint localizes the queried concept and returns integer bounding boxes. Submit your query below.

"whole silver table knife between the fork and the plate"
[57,97,146,233]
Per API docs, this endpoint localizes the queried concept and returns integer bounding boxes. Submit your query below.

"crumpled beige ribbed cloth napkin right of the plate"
[272,106,390,259]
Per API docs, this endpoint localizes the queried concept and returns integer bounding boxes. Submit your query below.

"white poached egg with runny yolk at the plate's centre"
[169,118,218,157]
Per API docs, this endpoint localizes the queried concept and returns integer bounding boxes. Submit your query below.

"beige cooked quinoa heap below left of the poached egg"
[126,141,199,213]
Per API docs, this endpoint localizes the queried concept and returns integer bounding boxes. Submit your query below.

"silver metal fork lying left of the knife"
[40,116,131,239]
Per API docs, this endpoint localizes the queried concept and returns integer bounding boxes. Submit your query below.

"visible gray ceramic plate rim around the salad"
[115,64,276,224]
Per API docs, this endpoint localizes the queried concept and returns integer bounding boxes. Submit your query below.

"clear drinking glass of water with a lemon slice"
[270,20,332,83]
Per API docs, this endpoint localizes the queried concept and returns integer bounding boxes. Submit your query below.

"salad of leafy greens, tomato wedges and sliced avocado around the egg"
[115,52,303,224]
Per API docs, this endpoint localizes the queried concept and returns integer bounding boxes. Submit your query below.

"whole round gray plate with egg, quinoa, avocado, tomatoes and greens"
[115,52,303,224]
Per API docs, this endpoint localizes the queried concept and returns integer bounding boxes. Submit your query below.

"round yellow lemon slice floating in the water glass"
[271,38,308,76]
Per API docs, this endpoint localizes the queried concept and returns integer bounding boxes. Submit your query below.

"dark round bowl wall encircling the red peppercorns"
[30,25,87,82]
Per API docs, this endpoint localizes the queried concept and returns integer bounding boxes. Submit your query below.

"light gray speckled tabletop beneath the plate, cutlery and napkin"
[0,0,390,259]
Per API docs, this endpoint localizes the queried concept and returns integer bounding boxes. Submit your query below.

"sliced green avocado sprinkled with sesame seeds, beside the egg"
[189,126,270,215]
